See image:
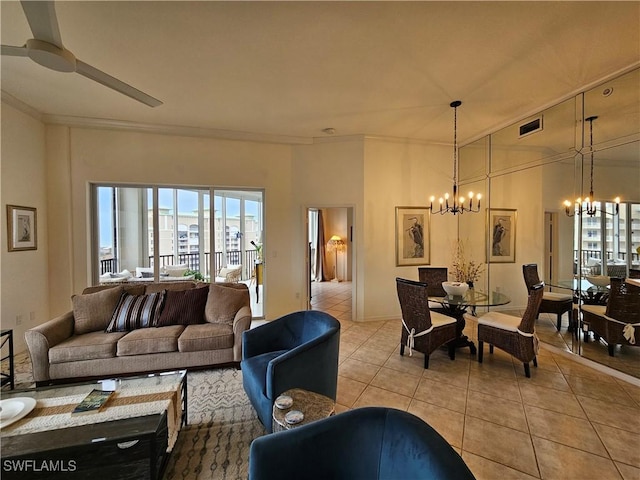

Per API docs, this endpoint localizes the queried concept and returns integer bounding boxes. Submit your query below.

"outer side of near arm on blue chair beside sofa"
[266,330,340,400]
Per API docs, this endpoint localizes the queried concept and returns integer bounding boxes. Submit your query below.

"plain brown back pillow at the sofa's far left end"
[71,286,122,335]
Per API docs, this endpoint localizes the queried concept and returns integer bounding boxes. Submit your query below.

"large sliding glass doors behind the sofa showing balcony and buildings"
[92,185,263,316]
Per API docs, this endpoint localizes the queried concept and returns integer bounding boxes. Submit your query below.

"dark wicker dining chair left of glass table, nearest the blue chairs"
[396,278,457,368]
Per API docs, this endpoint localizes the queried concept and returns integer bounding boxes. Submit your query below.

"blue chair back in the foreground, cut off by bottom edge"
[249,407,475,480]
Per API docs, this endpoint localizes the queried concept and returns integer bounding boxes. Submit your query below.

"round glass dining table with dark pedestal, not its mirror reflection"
[428,288,511,355]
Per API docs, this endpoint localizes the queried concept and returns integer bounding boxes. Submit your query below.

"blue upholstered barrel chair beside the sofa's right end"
[240,310,340,433]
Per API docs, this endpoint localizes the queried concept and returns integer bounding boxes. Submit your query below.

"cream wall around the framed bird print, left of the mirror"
[358,139,457,320]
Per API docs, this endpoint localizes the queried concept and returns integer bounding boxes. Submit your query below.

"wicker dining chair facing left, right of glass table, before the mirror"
[478,283,544,378]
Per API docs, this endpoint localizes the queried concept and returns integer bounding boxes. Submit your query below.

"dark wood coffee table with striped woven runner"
[0,370,187,479]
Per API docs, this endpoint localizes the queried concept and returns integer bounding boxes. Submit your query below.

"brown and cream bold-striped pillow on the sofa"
[107,290,166,333]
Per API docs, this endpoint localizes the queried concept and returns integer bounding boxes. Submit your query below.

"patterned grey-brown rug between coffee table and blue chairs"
[5,353,266,480]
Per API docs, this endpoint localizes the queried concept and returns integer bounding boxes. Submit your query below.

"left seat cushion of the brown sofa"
[49,331,126,363]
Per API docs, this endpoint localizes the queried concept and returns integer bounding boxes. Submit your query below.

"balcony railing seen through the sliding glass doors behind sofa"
[100,250,258,280]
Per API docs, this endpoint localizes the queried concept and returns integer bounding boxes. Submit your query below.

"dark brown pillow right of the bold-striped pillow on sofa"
[154,287,209,327]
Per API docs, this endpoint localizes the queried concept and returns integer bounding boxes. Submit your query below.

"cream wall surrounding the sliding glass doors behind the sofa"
[47,126,301,318]
